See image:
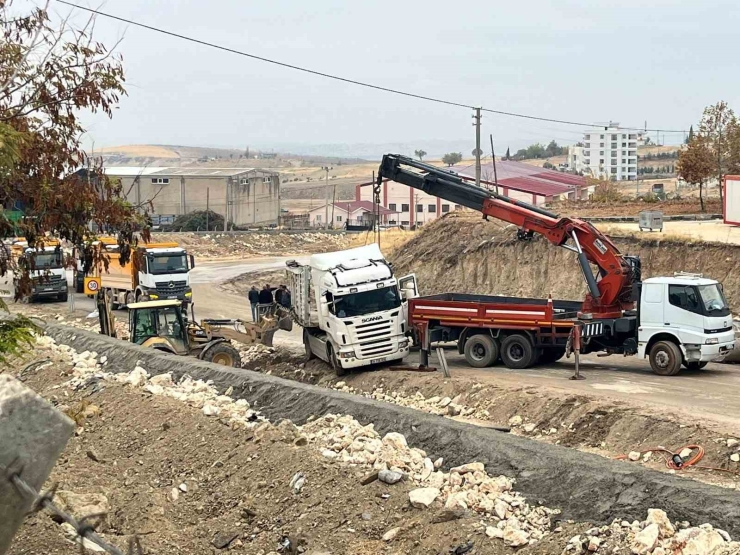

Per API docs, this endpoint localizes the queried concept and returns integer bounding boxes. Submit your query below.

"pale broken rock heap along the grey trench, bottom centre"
[300,414,559,547]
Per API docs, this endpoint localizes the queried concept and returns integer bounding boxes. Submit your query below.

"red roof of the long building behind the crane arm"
[448,160,586,197]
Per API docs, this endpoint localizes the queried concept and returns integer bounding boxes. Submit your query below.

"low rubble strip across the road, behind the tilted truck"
[154,231,350,259]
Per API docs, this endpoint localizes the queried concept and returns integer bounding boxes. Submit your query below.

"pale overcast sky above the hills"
[33,0,740,156]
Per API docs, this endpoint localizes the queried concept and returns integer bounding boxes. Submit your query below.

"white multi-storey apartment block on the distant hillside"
[582,122,642,181]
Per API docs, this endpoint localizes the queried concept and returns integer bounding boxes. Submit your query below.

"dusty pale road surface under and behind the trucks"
[62,257,740,428]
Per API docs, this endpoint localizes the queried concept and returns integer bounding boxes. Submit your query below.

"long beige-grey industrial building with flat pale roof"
[105,166,280,226]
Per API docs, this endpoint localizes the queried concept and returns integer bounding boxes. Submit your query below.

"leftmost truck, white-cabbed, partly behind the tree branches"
[12,239,69,302]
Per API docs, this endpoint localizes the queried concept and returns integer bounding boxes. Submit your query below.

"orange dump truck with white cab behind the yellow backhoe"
[90,237,195,308]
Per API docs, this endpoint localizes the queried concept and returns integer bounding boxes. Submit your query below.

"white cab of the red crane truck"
[637,273,735,376]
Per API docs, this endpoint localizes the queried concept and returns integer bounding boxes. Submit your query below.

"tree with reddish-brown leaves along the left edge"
[0,0,149,357]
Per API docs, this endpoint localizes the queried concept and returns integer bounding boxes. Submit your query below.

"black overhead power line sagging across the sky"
[57,0,686,133]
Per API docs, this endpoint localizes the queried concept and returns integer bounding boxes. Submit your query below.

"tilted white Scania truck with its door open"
[287,244,417,376]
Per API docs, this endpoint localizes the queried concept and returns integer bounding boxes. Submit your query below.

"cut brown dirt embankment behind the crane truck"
[391,214,740,313]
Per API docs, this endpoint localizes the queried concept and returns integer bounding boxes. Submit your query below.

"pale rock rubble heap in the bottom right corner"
[563,509,740,555]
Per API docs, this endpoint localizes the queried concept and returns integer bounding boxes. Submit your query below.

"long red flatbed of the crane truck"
[409,293,581,326]
